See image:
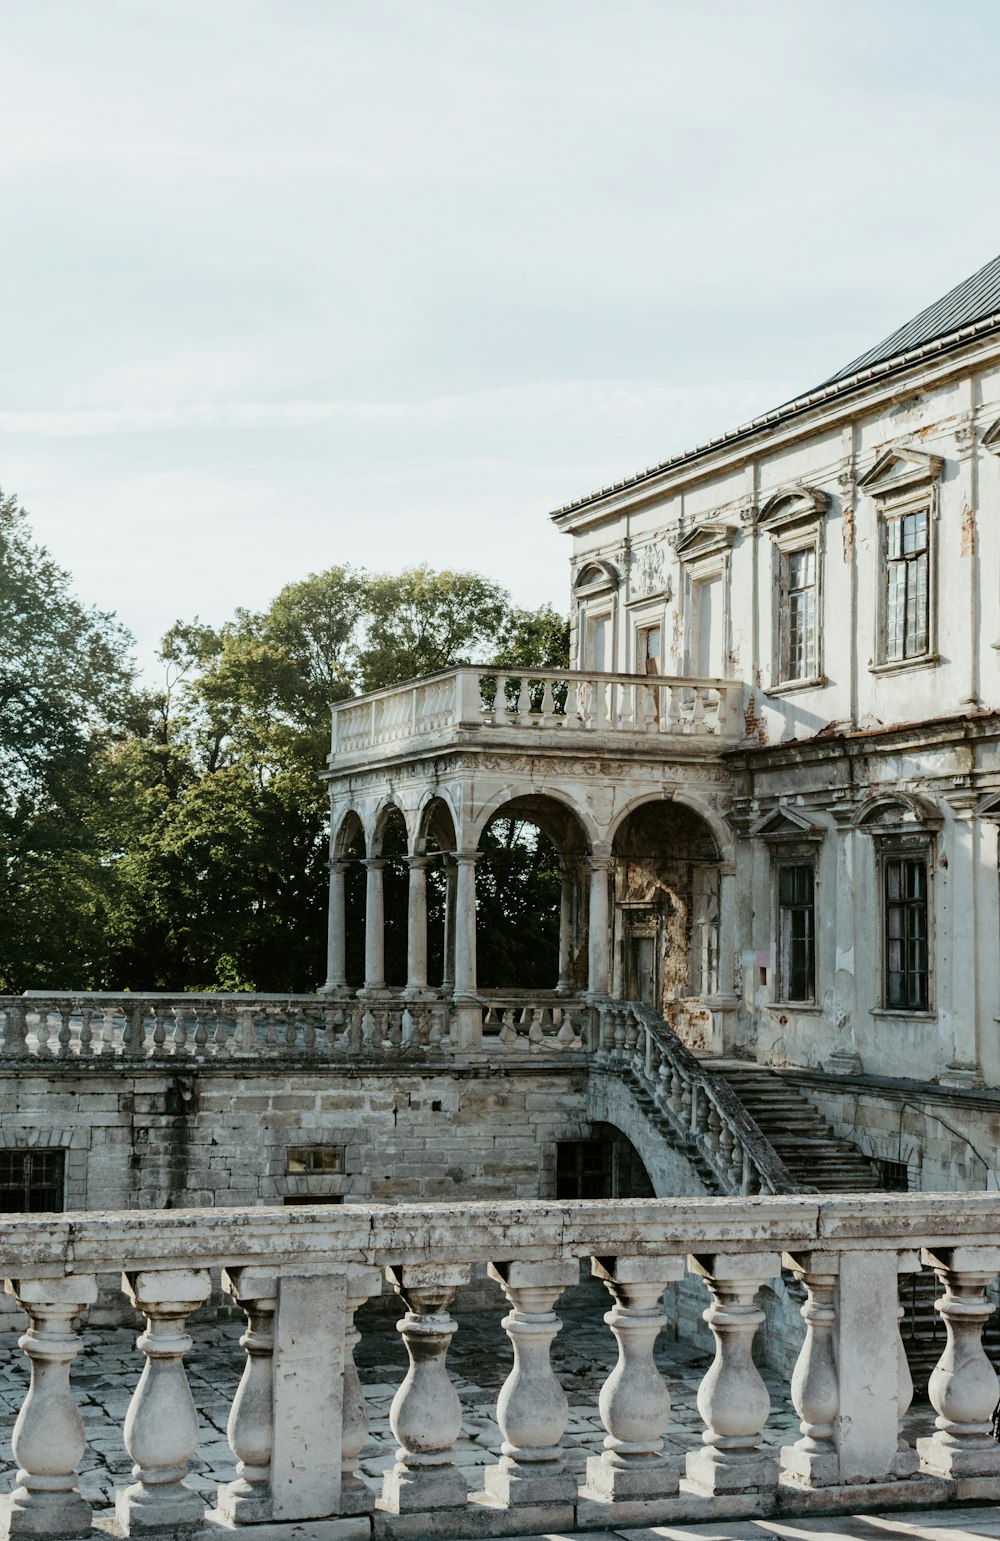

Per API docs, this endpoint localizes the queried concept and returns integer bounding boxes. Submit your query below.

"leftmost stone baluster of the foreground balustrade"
[0,1274,97,1536]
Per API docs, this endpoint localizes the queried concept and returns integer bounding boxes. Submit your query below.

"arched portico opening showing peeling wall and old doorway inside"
[612,801,720,1022]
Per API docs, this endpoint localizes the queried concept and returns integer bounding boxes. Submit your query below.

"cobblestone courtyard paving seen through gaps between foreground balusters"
[0,1284,934,1510]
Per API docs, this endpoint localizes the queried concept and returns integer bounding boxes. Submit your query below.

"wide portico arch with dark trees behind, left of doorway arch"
[476,795,587,992]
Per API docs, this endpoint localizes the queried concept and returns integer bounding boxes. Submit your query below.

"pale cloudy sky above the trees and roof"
[0,0,1000,678]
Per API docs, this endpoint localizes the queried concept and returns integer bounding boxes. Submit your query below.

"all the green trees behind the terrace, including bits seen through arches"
[0,499,565,991]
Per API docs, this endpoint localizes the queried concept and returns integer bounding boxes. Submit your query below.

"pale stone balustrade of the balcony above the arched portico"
[330,667,743,760]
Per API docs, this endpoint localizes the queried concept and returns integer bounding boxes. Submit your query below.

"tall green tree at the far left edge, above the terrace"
[0,495,143,991]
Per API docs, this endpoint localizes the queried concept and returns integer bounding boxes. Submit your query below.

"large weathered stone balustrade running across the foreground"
[0,1193,1000,1541]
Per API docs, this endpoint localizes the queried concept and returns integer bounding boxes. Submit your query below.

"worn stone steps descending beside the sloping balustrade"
[712,1059,880,1193]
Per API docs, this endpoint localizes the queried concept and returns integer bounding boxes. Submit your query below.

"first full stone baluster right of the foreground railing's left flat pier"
[379,1264,470,1515]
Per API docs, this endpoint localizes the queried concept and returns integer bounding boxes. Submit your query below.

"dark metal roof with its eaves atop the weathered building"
[550,256,1000,519]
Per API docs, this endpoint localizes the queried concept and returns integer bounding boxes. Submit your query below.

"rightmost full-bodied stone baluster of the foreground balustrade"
[917,1247,1000,1478]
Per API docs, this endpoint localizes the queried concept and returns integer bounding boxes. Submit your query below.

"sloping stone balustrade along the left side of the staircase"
[596,1000,815,1194]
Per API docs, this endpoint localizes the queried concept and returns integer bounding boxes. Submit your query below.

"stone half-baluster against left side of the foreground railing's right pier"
[781,1253,840,1487]
